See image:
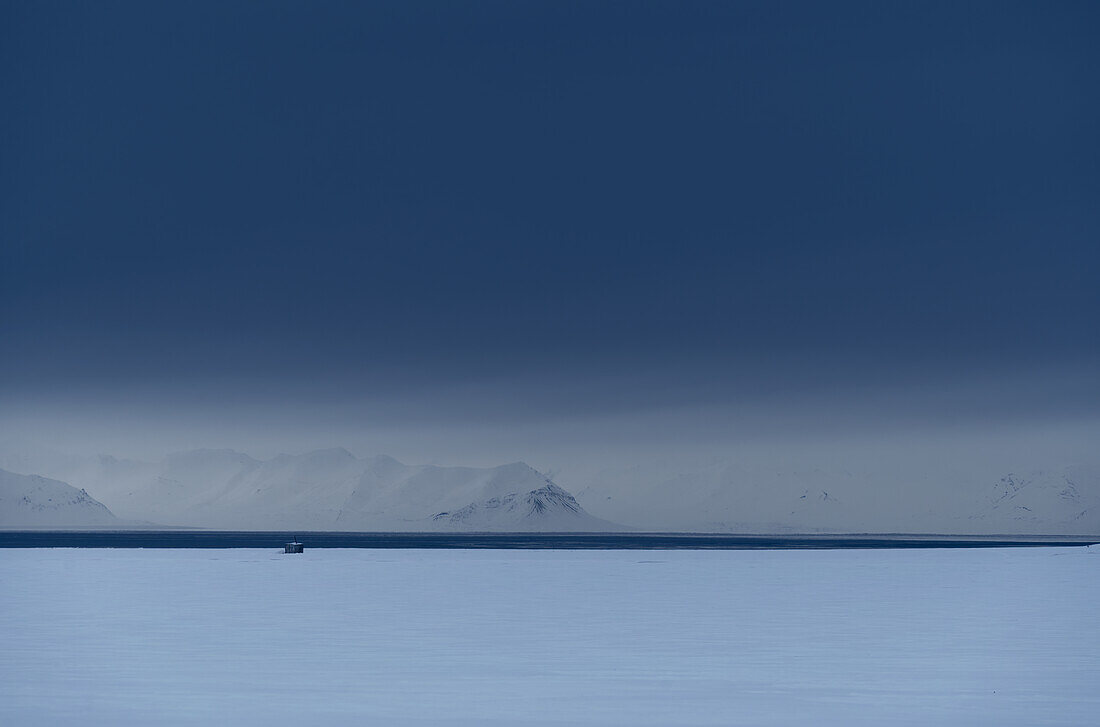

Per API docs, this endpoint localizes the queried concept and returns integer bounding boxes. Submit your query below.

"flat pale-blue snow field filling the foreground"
[0,547,1100,727]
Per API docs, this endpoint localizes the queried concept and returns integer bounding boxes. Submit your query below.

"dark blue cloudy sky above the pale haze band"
[0,0,1100,413]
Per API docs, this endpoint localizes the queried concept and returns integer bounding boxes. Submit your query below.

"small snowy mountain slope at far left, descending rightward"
[0,470,124,530]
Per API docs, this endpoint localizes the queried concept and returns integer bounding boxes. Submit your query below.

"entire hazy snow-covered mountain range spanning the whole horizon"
[0,448,1100,536]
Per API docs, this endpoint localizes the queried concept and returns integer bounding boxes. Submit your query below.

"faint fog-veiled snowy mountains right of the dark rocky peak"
[576,460,1100,535]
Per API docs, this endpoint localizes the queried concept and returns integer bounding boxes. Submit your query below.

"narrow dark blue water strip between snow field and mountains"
[0,530,1100,550]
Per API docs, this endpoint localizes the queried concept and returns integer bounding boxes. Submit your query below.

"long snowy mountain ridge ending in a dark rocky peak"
[19,449,620,531]
